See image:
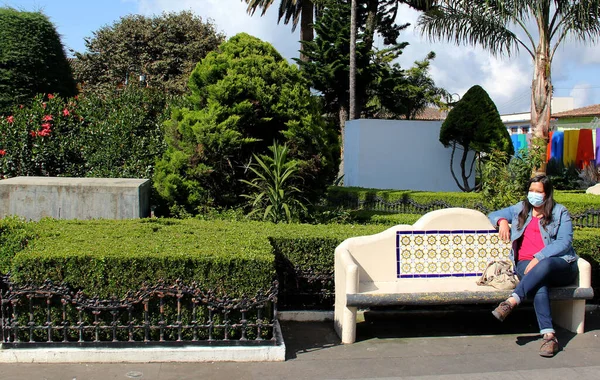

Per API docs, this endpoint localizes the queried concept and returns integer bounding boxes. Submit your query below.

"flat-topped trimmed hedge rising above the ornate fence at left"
[0,215,382,297]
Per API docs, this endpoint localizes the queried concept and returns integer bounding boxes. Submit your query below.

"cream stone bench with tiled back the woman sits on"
[334,208,593,343]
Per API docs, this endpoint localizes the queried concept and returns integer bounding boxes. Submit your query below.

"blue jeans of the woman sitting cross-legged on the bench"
[512,257,579,334]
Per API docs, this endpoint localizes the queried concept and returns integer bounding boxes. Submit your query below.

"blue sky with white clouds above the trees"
[0,0,600,114]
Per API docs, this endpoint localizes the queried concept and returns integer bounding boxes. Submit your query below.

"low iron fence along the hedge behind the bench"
[328,196,600,228]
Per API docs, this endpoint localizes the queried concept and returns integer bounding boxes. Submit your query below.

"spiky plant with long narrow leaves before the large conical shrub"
[241,142,306,223]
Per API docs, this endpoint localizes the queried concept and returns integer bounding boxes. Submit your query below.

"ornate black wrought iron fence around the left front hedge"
[0,276,280,348]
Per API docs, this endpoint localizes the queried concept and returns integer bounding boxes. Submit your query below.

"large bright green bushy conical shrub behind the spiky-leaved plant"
[155,33,339,213]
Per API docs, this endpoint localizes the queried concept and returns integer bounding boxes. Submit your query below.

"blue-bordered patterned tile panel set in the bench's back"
[396,230,511,278]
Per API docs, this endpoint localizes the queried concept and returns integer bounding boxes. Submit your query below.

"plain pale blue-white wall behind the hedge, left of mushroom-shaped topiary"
[344,119,475,191]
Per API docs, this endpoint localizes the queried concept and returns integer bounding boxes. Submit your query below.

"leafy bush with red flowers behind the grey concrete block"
[0,87,178,178]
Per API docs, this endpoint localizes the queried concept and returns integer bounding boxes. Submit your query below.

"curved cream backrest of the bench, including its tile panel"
[338,208,510,281]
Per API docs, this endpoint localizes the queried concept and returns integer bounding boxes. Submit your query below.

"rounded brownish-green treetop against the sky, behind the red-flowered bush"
[74,11,224,94]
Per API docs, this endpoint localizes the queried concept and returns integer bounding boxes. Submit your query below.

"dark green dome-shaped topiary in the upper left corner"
[0,8,77,115]
